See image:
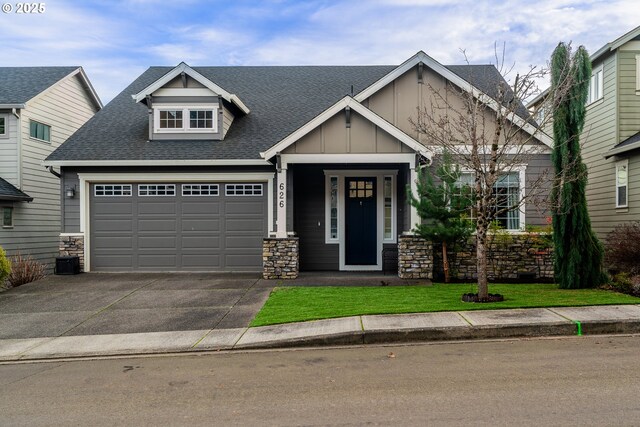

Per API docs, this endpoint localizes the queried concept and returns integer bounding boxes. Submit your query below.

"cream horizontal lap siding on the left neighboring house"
[0,75,97,267]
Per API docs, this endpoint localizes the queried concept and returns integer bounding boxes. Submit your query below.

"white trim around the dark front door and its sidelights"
[324,169,398,271]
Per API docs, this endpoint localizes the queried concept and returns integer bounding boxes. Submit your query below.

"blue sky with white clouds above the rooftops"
[0,0,640,104]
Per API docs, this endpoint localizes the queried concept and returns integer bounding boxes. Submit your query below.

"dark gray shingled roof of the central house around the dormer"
[46,65,526,161]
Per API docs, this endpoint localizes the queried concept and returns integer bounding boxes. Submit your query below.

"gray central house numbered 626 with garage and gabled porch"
[46,52,550,271]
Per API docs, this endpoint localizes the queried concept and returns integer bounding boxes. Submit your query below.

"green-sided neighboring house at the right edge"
[529,27,640,239]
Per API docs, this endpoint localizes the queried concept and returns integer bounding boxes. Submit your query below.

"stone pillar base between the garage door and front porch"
[262,237,300,279]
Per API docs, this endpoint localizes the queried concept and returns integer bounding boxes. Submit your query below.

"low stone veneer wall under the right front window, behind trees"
[434,233,554,281]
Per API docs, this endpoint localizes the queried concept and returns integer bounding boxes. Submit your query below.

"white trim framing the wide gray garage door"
[78,172,275,271]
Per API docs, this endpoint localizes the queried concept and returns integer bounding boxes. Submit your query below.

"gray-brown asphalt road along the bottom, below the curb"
[0,336,640,426]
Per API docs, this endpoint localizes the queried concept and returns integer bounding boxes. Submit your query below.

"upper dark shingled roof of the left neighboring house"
[0,67,80,105]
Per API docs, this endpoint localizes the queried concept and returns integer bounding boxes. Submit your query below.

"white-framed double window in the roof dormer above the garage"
[154,105,218,133]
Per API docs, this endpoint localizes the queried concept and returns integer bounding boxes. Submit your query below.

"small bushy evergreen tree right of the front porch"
[407,151,473,283]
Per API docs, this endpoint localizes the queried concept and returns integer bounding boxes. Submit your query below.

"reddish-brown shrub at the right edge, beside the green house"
[605,221,640,276]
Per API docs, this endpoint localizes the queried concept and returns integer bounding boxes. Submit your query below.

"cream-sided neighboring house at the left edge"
[0,67,102,267]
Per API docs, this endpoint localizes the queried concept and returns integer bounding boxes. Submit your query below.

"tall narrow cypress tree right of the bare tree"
[551,43,603,289]
